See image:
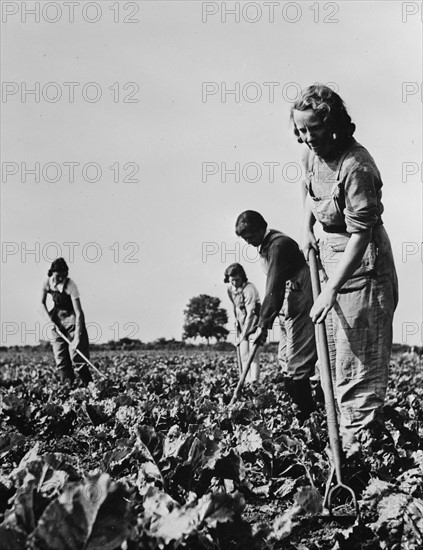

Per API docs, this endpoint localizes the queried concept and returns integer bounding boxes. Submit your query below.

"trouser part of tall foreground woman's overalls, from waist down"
[320,231,398,454]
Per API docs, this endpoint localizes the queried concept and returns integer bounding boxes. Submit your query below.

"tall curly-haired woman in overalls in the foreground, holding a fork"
[291,85,398,456]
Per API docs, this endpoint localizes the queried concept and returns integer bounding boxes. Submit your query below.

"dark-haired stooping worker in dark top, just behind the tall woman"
[235,210,317,421]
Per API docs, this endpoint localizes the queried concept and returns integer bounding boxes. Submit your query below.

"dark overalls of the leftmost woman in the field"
[48,279,92,383]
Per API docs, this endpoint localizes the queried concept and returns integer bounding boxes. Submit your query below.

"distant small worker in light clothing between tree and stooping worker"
[223,264,260,382]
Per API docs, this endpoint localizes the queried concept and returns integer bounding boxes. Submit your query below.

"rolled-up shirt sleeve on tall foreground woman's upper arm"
[343,155,382,233]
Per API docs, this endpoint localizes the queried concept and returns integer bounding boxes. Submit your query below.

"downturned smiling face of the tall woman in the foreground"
[293,109,335,157]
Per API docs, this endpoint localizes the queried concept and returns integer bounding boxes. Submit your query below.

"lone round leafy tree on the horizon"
[182,294,229,344]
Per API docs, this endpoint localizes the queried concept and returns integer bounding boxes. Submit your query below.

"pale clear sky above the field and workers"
[1,0,423,345]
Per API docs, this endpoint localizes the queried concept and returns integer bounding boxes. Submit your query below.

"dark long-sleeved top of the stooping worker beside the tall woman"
[259,229,306,329]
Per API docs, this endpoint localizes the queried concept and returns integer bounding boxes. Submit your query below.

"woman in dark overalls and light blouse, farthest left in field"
[41,258,92,385]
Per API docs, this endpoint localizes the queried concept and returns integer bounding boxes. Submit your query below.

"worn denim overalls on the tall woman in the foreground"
[307,143,398,451]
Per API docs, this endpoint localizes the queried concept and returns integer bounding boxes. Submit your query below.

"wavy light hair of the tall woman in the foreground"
[290,84,355,143]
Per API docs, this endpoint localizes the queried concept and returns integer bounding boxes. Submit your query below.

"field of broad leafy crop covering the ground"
[0,351,423,550]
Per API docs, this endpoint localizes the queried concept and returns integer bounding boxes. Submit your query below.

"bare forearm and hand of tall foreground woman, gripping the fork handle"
[310,228,372,323]
